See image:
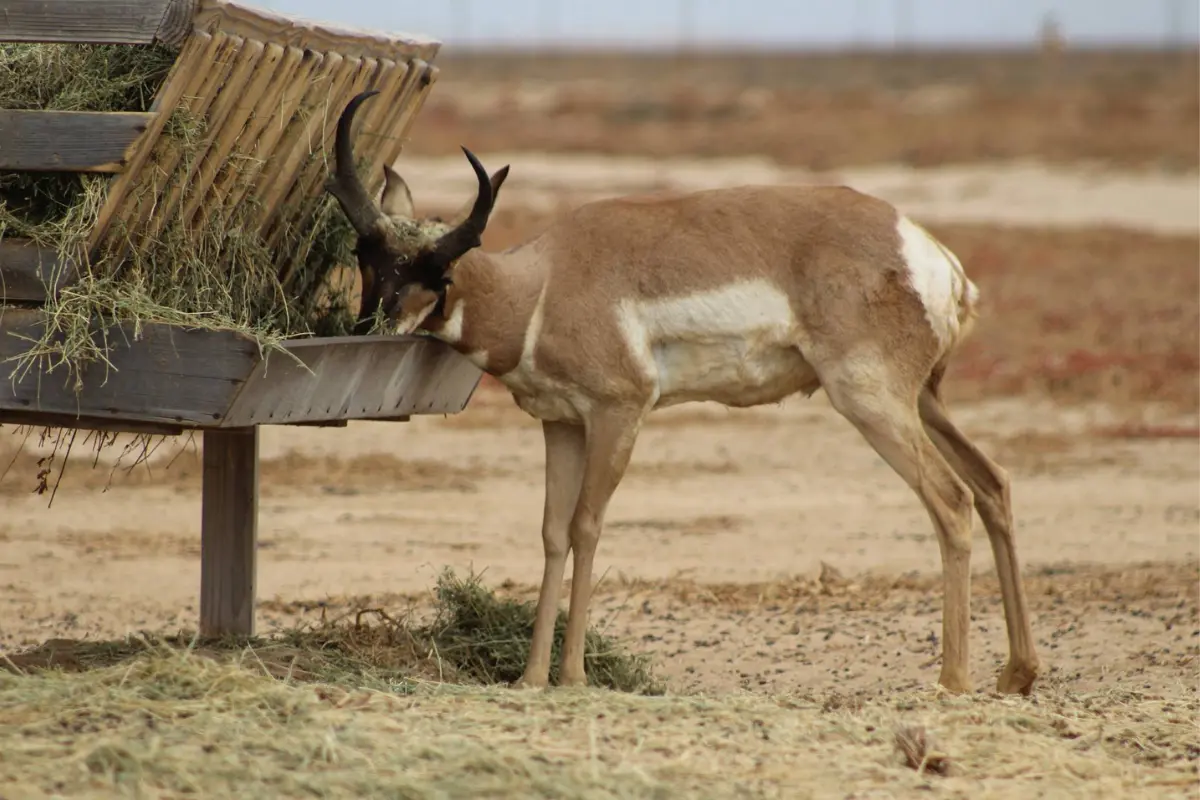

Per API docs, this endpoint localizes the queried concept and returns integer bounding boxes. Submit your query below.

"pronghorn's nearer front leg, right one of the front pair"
[558,408,644,686]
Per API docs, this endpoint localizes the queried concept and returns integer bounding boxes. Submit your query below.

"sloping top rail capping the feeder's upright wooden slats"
[194,0,440,61]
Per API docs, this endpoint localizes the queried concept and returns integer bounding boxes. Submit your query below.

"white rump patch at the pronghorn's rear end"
[896,215,978,348]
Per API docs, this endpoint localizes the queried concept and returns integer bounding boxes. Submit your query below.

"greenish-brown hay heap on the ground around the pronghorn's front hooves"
[0,570,662,694]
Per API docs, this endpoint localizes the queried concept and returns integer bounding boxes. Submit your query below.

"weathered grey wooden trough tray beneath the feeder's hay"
[0,308,482,429]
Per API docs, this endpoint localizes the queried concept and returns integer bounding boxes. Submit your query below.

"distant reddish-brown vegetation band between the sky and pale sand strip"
[408,50,1200,169]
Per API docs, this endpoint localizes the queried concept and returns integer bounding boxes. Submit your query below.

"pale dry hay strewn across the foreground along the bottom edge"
[0,646,1200,799]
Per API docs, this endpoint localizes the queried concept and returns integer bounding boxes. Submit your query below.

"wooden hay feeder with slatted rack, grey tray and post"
[0,0,481,636]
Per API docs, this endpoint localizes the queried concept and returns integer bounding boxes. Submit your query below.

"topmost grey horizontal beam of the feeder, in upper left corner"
[0,0,197,44]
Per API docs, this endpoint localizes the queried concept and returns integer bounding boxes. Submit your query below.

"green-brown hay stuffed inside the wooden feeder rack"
[0,44,354,386]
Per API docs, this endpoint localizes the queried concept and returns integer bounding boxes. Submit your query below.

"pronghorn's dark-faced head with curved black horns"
[325,91,509,333]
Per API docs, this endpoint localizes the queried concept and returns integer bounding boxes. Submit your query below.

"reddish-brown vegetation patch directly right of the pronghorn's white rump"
[932,225,1200,411]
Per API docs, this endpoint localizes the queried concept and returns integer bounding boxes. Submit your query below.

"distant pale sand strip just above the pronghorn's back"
[395,152,1200,234]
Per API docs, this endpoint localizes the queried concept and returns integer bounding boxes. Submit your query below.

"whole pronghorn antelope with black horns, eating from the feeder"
[326,92,1038,693]
